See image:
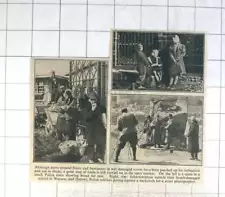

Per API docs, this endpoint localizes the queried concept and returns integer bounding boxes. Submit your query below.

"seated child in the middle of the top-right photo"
[148,49,162,87]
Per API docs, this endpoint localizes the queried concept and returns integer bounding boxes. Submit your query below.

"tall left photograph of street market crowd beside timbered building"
[32,59,108,164]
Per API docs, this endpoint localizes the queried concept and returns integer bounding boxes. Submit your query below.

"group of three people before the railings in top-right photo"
[134,35,186,90]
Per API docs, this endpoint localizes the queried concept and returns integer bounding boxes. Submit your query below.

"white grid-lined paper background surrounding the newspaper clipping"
[0,0,225,197]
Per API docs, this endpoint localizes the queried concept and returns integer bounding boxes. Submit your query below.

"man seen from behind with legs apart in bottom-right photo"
[114,108,138,162]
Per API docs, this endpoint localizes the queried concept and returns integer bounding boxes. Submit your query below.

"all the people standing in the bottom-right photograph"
[114,108,199,162]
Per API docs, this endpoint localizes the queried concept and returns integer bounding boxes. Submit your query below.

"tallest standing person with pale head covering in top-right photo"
[169,35,186,89]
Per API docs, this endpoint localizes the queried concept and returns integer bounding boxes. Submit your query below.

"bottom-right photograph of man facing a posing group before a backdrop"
[109,94,204,166]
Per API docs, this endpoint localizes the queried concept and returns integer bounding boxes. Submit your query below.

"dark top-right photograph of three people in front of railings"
[110,30,205,92]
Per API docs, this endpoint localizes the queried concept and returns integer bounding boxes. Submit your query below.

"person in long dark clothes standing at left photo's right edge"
[86,92,106,163]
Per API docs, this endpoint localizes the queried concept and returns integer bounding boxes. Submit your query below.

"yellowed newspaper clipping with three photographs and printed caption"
[30,30,206,184]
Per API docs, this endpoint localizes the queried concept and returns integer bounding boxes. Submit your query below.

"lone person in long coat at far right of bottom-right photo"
[186,116,199,160]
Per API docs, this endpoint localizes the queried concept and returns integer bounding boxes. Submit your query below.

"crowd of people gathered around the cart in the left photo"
[40,72,106,163]
